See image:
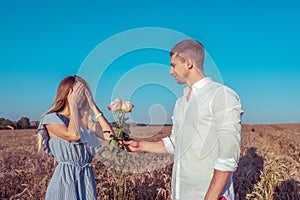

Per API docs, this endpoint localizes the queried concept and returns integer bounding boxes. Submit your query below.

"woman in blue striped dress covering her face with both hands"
[38,76,114,200]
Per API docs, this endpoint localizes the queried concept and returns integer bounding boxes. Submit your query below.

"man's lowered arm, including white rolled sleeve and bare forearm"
[205,88,243,200]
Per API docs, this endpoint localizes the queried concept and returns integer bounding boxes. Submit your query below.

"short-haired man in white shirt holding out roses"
[126,40,243,200]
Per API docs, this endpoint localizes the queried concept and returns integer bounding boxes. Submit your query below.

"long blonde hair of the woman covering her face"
[37,75,96,152]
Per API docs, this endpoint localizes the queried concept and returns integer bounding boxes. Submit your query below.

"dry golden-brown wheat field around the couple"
[0,124,300,200]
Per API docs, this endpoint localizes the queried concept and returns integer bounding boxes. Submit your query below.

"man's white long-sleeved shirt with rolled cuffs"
[163,78,243,200]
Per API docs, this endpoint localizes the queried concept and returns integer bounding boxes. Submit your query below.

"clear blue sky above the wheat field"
[0,0,300,124]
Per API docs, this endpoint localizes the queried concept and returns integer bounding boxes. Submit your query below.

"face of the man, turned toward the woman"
[170,54,187,84]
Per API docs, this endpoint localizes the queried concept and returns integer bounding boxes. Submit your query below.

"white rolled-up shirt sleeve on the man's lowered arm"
[212,88,243,171]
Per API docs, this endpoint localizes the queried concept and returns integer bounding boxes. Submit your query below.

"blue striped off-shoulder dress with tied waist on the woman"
[38,113,101,200]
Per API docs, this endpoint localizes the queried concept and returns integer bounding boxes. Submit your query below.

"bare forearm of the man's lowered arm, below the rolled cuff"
[205,169,232,200]
